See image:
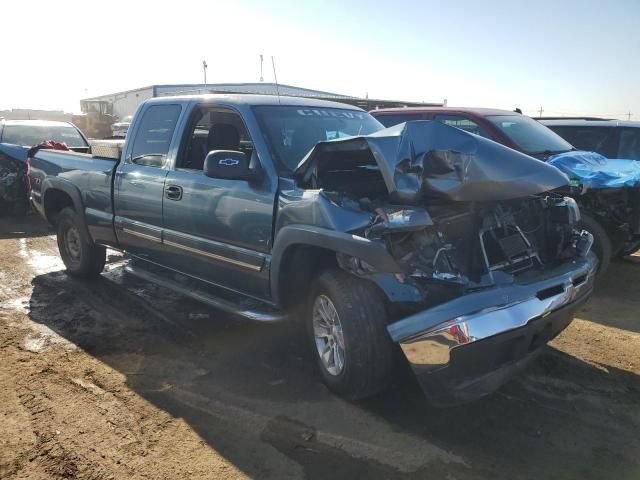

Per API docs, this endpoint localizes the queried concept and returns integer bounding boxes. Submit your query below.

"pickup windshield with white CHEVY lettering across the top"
[254,106,384,171]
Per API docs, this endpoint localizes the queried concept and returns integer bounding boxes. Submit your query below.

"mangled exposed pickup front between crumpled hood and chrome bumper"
[341,195,592,290]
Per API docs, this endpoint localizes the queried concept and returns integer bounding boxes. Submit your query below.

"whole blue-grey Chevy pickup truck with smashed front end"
[30,95,597,405]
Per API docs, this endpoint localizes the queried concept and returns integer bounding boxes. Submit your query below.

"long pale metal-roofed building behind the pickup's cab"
[80,82,442,118]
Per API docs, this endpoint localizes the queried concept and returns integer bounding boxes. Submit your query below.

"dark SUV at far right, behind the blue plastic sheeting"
[538,118,640,160]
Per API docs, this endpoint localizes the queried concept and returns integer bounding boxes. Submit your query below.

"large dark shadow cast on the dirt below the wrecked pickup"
[30,270,640,479]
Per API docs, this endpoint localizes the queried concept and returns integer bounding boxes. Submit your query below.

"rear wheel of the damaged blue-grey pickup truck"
[56,208,107,278]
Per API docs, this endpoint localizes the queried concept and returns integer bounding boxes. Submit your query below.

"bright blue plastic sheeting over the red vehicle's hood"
[547,151,640,188]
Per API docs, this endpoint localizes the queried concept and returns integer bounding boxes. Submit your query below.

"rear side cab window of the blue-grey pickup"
[131,104,182,168]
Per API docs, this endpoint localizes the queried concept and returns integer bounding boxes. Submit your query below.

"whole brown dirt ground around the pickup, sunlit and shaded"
[0,216,640,480]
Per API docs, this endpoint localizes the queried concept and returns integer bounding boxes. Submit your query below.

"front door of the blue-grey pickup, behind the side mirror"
[163,104,277,298]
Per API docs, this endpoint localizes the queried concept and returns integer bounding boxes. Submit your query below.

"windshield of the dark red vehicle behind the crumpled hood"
[487,115,573,155]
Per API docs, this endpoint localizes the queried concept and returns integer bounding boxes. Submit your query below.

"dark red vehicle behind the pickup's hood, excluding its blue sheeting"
[370,107,640,274]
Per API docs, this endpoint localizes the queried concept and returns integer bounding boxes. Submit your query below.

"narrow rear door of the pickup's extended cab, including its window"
[114,103,182,261]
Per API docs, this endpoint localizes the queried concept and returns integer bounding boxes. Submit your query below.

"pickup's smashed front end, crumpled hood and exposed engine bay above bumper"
[296,122,593,303]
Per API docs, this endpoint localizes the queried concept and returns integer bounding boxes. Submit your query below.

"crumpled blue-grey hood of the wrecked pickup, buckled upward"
[295,121,568,204]
